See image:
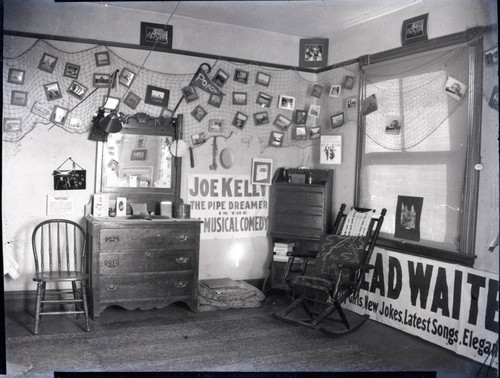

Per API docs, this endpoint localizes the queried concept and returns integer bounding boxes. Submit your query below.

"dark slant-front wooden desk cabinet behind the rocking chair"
[265,168,333,289]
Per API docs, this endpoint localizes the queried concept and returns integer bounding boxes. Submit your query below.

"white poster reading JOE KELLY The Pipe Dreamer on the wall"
[186,174,269,239]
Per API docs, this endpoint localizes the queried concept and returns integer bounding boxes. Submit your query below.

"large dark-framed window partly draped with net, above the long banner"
[356,36,482,265]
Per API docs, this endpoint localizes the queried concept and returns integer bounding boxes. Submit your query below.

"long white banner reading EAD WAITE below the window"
[346,249,499,368]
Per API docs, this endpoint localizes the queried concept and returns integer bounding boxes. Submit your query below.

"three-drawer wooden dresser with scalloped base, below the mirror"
[87,216,201,319]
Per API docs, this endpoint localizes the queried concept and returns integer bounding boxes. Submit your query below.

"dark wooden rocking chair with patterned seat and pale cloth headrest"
[272,204,386,335]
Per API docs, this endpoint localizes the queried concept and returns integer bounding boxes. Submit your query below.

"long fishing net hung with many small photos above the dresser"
[2,40,357,149]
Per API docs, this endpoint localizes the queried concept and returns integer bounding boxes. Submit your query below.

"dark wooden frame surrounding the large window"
[354,27,484,267]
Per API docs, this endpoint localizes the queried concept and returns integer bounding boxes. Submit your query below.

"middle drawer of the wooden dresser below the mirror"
[99,250,194,274]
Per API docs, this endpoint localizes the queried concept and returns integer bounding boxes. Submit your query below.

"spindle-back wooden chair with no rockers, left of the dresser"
[31,219,90,334]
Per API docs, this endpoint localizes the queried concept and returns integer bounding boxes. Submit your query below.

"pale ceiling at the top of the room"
[101,0,423,38]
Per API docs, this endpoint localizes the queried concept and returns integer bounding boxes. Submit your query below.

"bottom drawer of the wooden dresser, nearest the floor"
[99,272,195,301]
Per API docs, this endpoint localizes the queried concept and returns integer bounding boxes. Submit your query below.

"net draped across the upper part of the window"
[361,46,469,150]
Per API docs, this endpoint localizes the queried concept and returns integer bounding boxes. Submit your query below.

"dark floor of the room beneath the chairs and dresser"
[1,294,497,378]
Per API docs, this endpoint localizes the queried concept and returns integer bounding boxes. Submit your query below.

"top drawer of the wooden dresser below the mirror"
[99,228,198,251]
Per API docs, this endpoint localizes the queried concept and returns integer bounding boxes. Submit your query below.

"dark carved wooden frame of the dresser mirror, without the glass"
[95,113,182,215]
